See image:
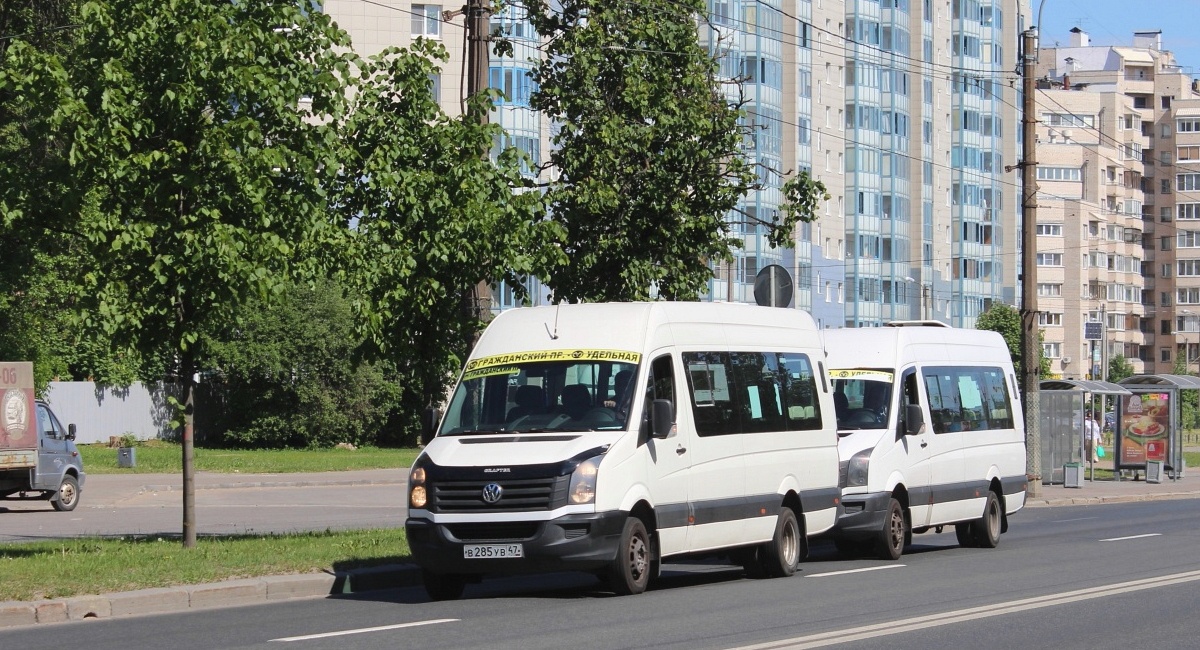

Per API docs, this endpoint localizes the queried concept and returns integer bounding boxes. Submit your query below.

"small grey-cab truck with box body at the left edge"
[0,361,86,512]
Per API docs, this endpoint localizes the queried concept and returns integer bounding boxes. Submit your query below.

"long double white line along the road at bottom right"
[732,571,1200,650]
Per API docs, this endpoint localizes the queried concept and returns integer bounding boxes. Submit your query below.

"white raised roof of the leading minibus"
[472,302,821,357]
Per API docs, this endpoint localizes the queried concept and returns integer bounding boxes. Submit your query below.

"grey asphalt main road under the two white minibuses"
[0,499,1200,650]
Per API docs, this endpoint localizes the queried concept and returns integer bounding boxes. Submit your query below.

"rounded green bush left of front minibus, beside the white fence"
[197,279,402,449]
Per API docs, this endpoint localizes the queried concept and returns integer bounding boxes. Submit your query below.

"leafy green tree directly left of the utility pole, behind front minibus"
[336,40,562,404]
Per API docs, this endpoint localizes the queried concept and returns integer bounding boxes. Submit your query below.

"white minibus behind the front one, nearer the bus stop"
[824,321,1027,560]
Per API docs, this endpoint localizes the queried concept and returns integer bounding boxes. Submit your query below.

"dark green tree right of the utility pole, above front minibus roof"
[529,0,828,301]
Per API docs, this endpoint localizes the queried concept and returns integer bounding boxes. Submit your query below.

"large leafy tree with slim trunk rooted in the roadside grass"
[0,0,353,547]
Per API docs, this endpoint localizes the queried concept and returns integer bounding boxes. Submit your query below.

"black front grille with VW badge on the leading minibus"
[430,476,570,512]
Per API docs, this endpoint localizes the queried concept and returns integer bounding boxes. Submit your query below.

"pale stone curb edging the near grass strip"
[0,564,421,630]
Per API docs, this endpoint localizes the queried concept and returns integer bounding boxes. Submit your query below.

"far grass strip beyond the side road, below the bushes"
[79,440,420,474]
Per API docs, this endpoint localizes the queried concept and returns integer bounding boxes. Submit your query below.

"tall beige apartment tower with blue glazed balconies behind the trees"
[324,0,1030,327]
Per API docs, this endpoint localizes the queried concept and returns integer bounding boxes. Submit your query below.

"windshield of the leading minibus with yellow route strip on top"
[438,353,640,435]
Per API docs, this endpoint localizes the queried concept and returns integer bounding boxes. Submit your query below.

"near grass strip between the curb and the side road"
[0,529,409,602]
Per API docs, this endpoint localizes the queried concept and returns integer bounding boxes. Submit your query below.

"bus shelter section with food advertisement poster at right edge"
[1112,374,1200,481]
